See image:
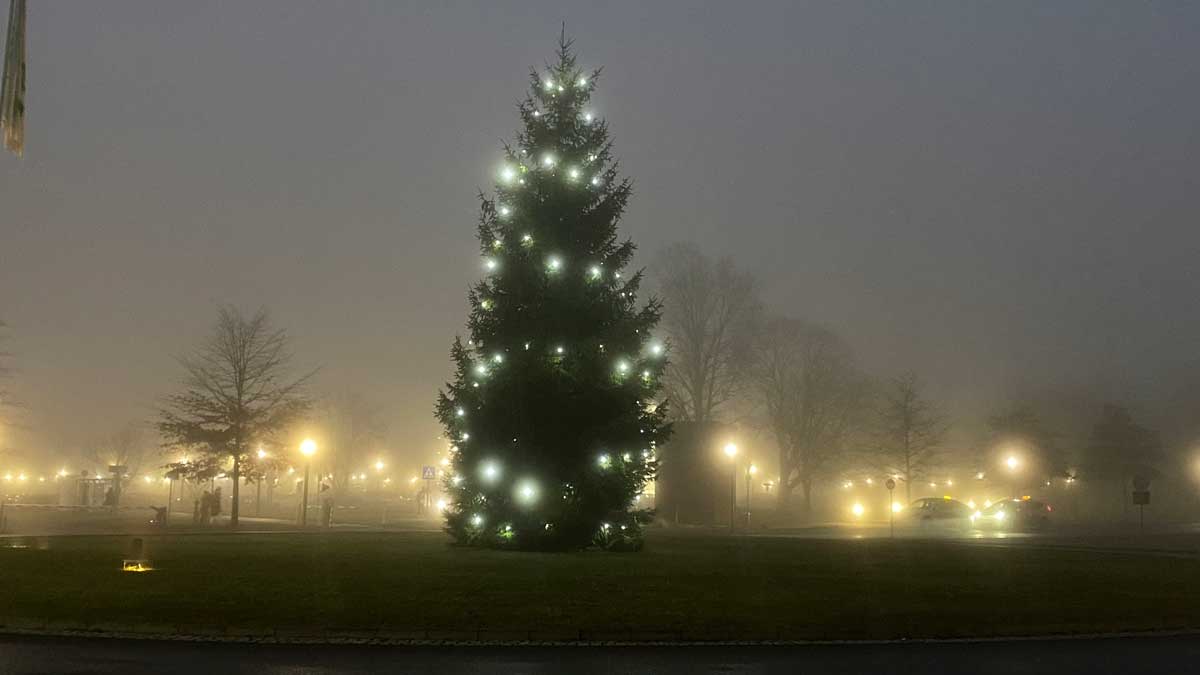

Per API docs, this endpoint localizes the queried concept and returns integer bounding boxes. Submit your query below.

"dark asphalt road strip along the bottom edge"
[0,635,1200,675]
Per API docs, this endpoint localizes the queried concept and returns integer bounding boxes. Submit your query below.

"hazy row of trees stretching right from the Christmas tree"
[652,244,1165,516]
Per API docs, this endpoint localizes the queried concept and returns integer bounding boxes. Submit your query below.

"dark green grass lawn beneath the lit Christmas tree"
[0,533,1200,639]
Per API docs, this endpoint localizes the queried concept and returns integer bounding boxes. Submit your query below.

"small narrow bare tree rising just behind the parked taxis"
[876,372,947,503]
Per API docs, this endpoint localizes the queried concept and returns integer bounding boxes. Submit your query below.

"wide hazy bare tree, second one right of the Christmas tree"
[751,318,869,516]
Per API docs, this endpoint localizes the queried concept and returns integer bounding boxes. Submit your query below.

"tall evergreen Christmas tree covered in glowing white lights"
[437,37,670,550]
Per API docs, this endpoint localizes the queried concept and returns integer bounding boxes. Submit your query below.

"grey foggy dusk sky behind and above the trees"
[0,0,1200,468]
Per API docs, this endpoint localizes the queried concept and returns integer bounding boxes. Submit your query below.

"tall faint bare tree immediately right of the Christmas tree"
[654,244,762,423]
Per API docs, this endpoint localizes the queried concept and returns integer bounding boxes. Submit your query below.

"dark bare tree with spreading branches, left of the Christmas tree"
[158,306,316,527]
